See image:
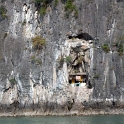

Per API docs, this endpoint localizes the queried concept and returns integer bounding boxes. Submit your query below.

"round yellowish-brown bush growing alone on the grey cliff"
[32,36,46,50]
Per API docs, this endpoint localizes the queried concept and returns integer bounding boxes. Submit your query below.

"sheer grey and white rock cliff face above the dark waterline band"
[0,0,124,112]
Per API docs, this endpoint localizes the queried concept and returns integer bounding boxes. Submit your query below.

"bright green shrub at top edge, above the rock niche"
[65,0,78,18]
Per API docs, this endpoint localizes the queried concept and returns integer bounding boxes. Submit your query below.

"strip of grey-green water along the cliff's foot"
[0,115,124,124]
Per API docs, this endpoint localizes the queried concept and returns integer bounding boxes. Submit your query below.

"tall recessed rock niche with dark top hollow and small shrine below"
[67,33,93,89]
